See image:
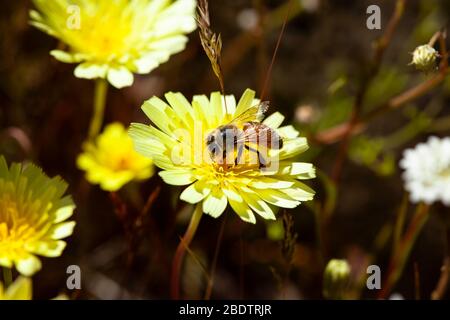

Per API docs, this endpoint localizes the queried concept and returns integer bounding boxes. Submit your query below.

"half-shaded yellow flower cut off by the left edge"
[0,157,75,276]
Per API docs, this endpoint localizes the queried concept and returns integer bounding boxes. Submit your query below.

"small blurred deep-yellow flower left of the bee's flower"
[77,123,154,191]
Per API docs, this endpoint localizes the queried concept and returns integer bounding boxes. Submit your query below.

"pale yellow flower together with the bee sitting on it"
[129,90,315,223]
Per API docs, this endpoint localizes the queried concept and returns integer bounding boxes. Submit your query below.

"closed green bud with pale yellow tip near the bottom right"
[323,259,350,299]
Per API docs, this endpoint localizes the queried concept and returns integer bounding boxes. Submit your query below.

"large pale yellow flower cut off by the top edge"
[30,0,196,88]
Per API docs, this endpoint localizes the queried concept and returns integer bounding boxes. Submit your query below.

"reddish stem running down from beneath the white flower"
[378,204,429,299]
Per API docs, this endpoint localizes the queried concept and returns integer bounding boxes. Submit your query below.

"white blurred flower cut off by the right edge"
[400,137,450,206]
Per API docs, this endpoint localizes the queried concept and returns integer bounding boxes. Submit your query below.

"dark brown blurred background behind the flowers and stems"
[0,0,450,299]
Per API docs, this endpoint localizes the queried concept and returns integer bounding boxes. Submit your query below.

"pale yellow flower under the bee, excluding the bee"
[129,90,315,223]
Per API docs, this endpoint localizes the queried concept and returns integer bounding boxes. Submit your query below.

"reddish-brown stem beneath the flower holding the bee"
[171,203,203,300]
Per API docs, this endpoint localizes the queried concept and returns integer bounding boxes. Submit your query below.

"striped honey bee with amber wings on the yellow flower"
[206,101,283,169]
